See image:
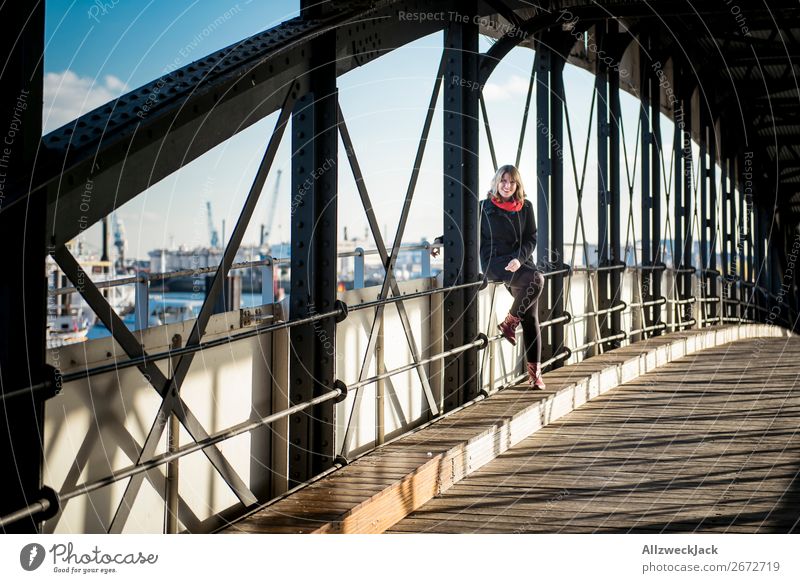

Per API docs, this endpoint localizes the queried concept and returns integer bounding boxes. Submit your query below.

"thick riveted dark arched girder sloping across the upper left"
[4,0,468,246]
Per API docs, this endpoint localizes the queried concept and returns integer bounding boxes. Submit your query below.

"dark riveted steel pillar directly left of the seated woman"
[442,0,484,411]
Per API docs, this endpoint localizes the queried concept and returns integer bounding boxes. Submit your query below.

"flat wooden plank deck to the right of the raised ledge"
[389,336,800,533]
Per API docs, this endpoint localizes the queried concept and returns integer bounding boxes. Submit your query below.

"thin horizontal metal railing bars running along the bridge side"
[0,253,788,527]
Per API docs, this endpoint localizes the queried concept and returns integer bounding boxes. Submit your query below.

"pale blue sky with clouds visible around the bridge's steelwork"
[43,0,688,258]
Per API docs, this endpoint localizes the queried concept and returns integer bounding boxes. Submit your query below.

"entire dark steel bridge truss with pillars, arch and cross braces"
[0,0,800,532]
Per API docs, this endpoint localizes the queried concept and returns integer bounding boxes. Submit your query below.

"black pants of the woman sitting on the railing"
[487,265,544,362]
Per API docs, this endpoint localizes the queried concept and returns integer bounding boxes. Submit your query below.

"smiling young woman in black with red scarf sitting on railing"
[481,165,545,389]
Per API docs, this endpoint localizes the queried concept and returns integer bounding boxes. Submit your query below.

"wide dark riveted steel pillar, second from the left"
[289,33,338,487]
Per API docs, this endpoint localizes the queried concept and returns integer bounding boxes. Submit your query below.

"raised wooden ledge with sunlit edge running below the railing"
[219,325,794,533]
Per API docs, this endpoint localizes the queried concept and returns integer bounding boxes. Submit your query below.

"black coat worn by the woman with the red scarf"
[481,199,536,279]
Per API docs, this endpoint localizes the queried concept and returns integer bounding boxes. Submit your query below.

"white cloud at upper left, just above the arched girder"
[42,70,128,133]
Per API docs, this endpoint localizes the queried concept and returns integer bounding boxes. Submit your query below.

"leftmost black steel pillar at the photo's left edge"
[0,2,47,533]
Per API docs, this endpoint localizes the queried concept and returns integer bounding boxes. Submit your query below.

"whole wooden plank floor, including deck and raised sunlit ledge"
[222,326,800,532]
